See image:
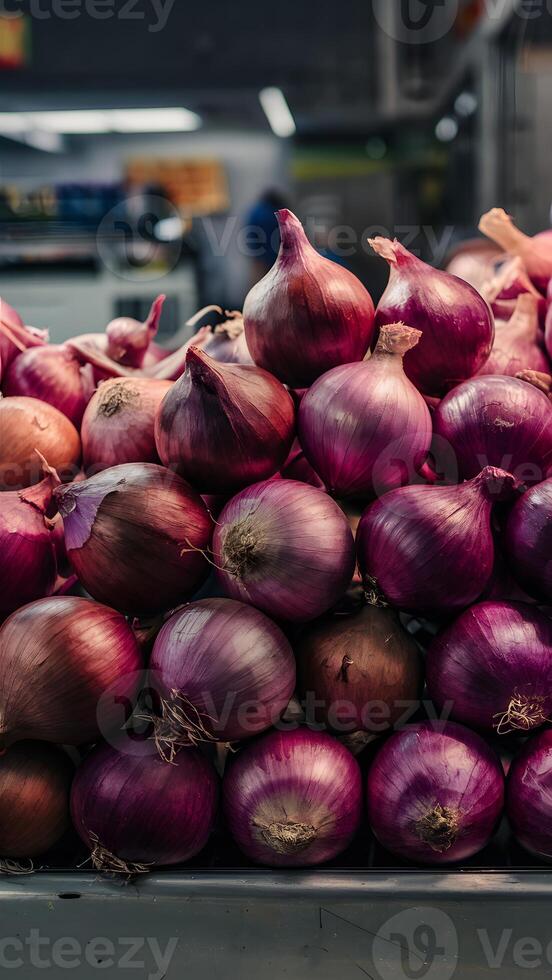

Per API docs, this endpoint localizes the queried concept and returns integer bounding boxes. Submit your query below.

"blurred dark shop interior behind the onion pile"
[0,0,552,346]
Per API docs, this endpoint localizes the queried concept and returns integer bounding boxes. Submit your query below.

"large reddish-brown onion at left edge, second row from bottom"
[0,596,143,748]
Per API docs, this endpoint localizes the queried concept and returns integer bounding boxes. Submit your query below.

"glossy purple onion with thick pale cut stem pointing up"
[299,323,432,497]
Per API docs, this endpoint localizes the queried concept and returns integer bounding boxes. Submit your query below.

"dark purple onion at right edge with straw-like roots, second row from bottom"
[426,602,552,734]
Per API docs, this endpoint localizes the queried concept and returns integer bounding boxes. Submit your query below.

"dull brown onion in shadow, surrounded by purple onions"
[297,606,422,734]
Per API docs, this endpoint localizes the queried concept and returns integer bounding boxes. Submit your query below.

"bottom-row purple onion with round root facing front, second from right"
[367,722,504,864]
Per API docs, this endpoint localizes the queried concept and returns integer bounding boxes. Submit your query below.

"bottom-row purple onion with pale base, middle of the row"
[223,728,362,867]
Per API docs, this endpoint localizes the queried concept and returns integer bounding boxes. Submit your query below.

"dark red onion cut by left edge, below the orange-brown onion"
[0,462,59,618]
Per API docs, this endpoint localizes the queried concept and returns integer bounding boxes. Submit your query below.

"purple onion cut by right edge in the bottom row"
[506,729,552,861]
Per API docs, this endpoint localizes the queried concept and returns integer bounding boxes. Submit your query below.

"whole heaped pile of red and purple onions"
[0,209,552,880]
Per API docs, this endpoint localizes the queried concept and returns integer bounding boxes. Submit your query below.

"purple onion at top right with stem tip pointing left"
[370,238,494,395]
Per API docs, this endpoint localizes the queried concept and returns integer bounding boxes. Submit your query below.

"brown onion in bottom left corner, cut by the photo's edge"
[0,742,73,858]
